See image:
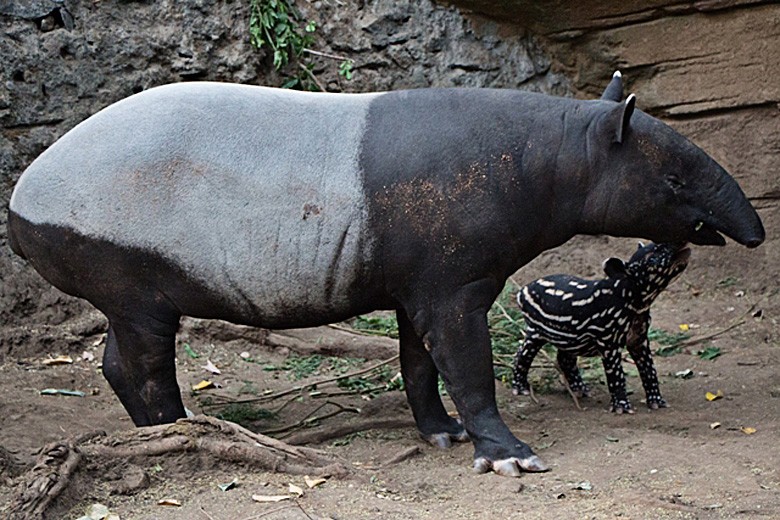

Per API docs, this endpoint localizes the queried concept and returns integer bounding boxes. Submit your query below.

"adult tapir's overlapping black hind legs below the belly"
[103,316,185,426]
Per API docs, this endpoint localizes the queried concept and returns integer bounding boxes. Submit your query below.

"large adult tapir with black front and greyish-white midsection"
[8,75,764,475]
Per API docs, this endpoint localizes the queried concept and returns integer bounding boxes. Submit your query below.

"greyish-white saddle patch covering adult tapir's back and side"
[11,84,382,322]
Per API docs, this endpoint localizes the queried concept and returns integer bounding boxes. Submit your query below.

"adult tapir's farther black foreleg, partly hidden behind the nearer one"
[396,309,468,448]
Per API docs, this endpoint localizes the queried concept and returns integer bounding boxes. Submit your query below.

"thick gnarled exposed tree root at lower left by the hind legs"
[0,415,349,520]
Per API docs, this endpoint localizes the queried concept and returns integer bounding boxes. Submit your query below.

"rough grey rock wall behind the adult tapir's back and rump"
[0,0,569,356]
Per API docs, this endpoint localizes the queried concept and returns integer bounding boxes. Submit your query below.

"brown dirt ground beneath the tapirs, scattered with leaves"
[0,238,780,520]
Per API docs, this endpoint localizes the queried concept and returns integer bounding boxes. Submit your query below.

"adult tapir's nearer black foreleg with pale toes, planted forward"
[410,292,547,476]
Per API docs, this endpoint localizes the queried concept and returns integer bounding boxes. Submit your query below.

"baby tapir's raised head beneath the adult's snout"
[604,243,691,310]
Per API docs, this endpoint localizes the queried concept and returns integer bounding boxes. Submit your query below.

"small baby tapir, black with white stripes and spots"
[512,244,690,413]
